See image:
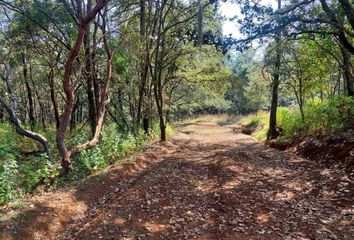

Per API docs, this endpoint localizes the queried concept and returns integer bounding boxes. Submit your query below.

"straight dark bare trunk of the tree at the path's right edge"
[267,0,281,139]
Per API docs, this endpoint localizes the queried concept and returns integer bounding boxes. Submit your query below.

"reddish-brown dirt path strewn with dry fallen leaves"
[0,121,354,240]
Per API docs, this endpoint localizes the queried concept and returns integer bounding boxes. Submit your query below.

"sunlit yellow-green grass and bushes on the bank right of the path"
[239,97,354,140]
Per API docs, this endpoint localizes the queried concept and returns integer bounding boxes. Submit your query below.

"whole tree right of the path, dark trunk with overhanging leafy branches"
[233,0,354,138]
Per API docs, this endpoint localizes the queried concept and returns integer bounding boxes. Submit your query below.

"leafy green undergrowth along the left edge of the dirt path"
[0,124,164,205]
